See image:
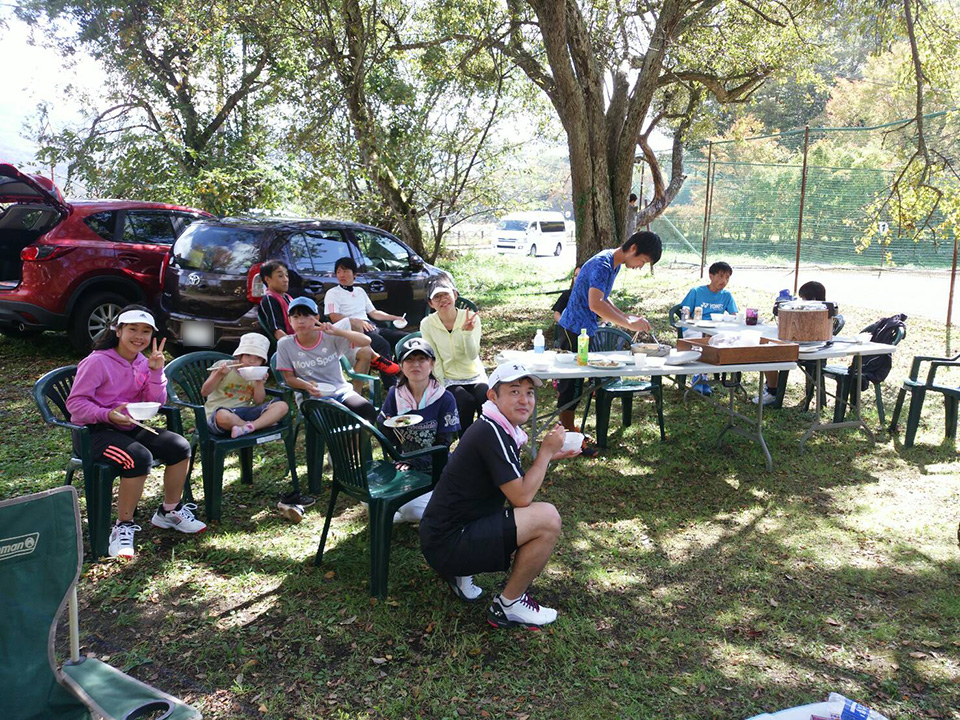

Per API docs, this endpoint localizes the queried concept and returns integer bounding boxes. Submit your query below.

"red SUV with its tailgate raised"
[0,164,212,352]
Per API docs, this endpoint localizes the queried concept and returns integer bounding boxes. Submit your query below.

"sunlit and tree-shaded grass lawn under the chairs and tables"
[0,255,960,720]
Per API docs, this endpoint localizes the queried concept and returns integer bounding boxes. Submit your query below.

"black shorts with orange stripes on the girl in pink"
[89,423,190,478]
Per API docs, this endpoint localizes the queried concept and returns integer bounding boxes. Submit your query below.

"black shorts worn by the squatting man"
[420,508,517,576]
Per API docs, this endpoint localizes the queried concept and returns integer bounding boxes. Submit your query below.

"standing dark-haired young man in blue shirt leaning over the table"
[557,230,663,457]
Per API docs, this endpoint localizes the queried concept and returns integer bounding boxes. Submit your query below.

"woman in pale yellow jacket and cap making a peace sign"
[420,281,487,435]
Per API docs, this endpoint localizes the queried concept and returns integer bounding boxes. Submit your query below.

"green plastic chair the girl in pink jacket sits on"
[33,365,193,560]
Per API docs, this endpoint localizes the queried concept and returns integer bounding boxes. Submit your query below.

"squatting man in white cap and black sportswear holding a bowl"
[420,363,580,629]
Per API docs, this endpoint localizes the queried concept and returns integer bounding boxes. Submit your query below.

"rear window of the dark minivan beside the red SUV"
[173,223,262,273]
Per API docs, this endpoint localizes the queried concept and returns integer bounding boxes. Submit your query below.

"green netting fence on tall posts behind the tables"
[651,111,960,270]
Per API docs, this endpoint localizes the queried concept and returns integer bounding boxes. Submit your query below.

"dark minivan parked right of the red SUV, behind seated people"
[160,219,446,349]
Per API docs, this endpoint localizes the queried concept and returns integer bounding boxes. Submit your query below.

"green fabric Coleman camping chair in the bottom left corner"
[0,487,201,720]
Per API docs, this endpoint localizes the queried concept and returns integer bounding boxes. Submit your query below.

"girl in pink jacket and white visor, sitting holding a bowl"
[67,305,207,558]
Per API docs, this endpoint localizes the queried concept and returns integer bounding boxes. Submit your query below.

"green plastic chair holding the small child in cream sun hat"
[163,350,300,522]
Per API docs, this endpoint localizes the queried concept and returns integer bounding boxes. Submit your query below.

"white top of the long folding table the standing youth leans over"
[497,350,797,380]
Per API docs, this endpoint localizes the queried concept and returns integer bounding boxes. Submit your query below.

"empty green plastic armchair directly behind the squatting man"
[302,398,447,598]
